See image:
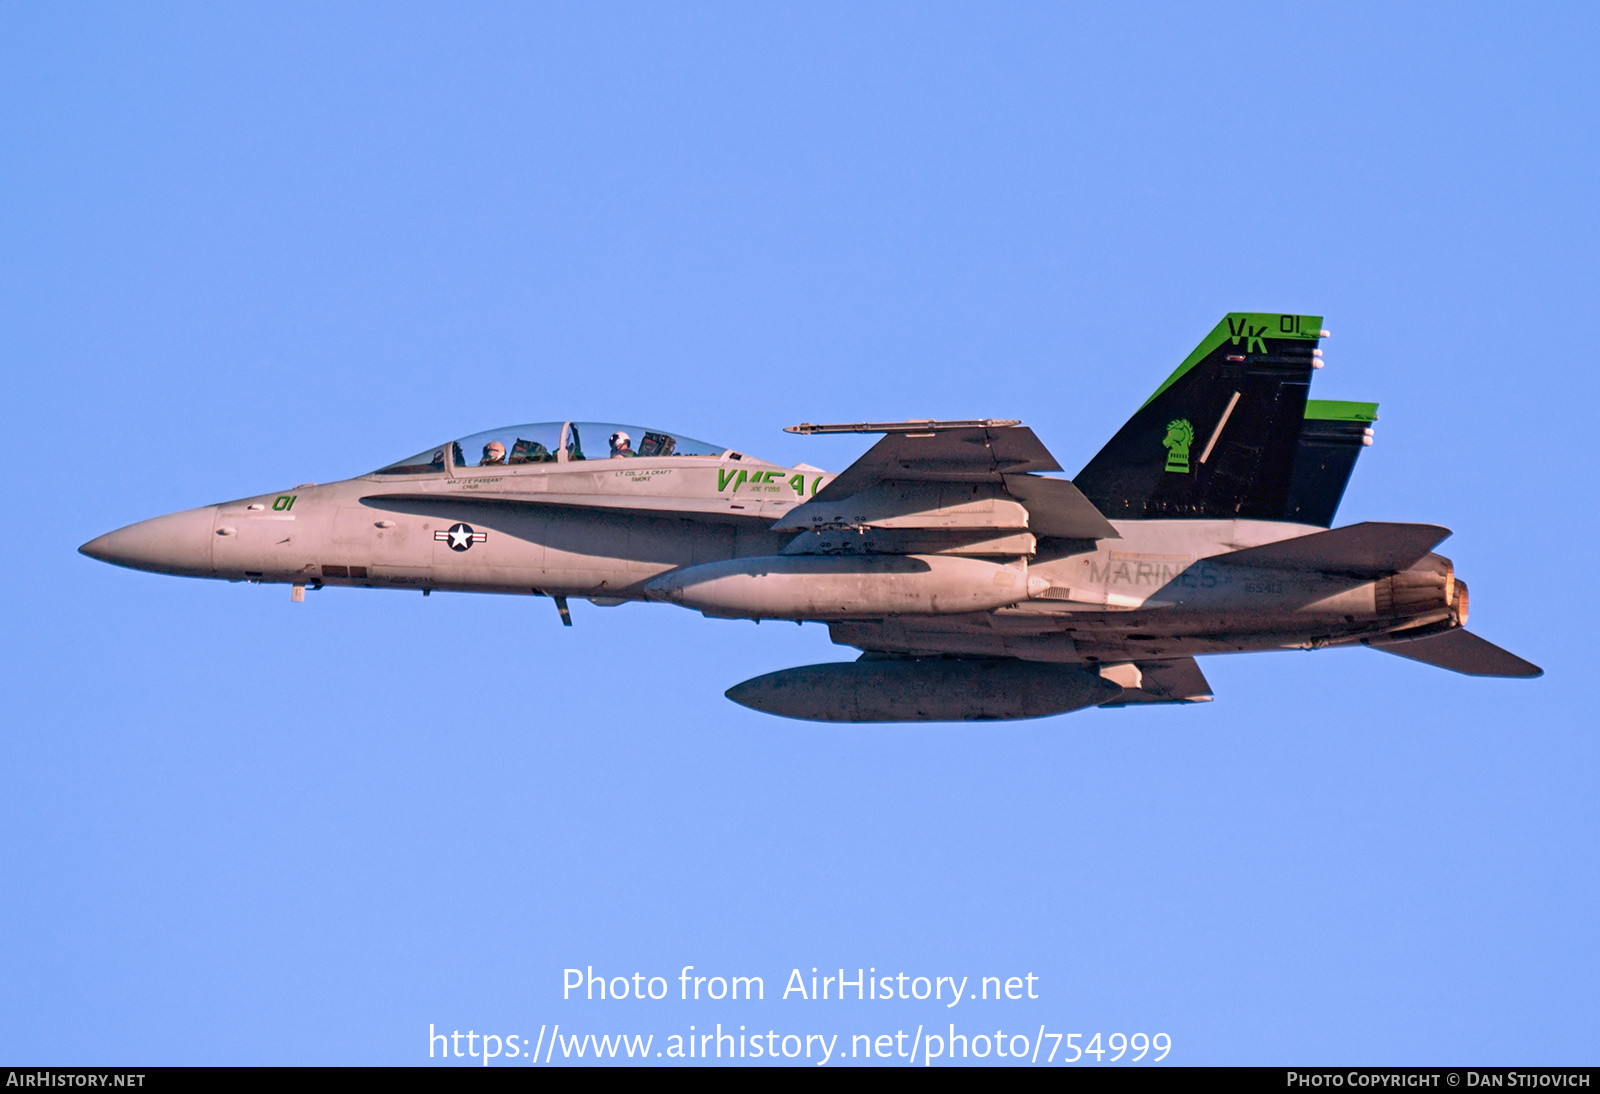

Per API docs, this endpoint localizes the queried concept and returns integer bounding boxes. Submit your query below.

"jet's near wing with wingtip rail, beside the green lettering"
[774,422,1118,539]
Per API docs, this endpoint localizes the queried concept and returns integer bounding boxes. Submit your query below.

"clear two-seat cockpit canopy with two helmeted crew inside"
[376,422,728,475]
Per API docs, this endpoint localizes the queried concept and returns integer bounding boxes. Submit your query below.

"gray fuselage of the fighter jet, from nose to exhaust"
[83,453,1454,662]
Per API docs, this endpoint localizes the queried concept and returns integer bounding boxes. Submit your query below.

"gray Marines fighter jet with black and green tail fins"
[80,312,1541,723]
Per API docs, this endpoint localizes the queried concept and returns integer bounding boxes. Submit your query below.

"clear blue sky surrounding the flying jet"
[0,3,1600,1064]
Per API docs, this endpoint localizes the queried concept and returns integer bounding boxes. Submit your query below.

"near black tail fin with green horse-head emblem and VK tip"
[1072,312,1322,520]
